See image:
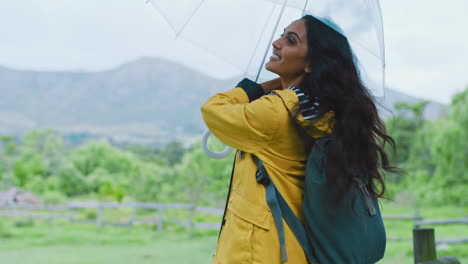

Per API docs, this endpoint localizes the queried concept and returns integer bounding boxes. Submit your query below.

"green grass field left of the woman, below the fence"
[0,224,217,264]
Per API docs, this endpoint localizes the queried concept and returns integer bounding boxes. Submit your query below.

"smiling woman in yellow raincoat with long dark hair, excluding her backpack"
[201,15,394,264]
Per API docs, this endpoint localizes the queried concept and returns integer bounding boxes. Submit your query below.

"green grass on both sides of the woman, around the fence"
[0,204,468,264]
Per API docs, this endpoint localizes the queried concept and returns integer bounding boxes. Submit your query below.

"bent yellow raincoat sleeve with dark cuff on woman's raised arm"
[201,79,281,153]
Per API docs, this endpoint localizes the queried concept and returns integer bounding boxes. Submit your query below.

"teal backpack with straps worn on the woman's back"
[256,138,386,264]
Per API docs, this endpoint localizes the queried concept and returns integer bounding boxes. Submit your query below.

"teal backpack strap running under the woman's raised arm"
[255,157,318,263]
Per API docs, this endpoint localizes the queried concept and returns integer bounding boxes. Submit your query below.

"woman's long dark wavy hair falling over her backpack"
[296,15,400,200]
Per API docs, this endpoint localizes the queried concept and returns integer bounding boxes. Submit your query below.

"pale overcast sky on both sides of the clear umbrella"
[0,0,468,103]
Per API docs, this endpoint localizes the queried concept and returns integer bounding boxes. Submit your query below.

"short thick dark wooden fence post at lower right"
[413,228,437,264]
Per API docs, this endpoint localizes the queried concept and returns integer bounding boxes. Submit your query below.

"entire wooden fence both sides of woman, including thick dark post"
[0,202,468,264]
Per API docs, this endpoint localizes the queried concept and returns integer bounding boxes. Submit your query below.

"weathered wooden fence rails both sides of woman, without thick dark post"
[0,202,468,244]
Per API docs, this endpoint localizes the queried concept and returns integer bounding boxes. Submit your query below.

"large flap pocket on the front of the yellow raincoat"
[213,192,271,264]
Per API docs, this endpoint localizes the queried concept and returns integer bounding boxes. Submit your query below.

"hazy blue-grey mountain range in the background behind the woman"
[0,58,445,144]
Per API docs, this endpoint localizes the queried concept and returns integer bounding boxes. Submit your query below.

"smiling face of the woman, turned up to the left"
[265,19,309,79]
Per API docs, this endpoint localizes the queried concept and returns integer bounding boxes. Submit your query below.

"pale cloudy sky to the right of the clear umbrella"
[382,0,468,103]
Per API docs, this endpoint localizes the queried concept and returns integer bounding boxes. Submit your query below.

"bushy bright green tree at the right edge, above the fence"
[406,88,468,204]
